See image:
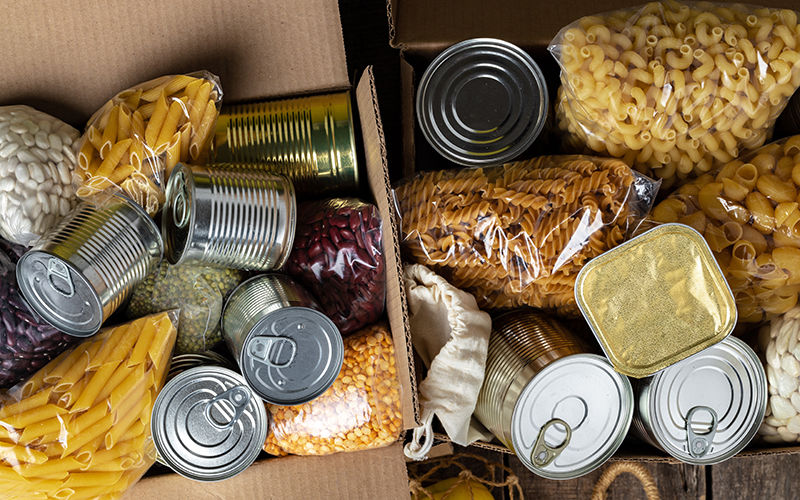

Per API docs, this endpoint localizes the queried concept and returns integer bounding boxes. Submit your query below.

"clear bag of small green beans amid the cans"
[125,261,244,354]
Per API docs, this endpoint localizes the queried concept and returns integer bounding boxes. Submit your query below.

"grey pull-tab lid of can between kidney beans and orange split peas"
[244,307,344,406]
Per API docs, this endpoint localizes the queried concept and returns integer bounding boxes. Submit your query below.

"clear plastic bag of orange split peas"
[264,324,403,455]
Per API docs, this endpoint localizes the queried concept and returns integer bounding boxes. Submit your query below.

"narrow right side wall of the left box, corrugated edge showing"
[356,66,419,429]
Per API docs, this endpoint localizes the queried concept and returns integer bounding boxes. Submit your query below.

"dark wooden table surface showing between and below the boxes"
[339,0,800,500]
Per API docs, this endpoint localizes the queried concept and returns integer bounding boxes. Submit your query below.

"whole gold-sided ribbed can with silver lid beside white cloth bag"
[475,310,633,479]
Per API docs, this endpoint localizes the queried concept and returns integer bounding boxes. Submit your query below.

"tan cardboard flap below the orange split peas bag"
[129,443,408,500]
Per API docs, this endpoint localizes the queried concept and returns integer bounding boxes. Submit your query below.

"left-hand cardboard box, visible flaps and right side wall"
[0,0,418,500]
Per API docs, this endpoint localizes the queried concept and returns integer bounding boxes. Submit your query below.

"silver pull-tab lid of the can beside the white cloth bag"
[511,354,633,479]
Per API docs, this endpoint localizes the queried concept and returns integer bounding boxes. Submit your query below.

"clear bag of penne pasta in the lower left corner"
[0,311,177,500]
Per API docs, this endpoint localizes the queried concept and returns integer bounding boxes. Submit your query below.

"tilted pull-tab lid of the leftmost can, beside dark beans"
[17,250,103,337]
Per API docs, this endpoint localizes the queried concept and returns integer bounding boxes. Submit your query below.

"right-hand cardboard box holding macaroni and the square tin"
[387,0,800,464]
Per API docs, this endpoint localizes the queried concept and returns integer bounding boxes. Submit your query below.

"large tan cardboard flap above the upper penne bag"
[0,0,349,126]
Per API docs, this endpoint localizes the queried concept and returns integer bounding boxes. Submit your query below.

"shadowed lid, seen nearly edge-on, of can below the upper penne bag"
[161,163,195,264]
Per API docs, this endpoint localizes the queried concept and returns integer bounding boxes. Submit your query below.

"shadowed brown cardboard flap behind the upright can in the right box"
[387,0,797,52]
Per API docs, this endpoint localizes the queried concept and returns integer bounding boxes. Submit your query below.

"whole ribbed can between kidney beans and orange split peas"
[222,274,344,406]
